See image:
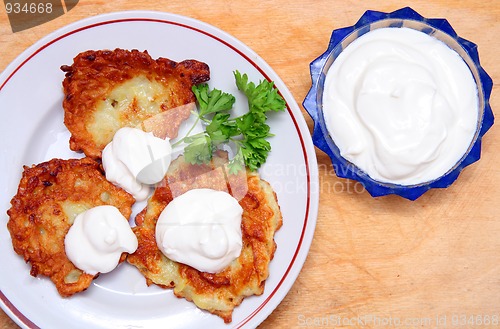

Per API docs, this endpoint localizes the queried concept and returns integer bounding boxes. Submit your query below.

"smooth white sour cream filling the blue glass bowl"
[323,28,479,185]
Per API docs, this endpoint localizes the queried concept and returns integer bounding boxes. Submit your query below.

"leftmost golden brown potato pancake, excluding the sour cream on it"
[7,158,135,297]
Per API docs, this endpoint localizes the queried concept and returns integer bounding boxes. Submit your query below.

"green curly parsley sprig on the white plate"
[182,71,286,173]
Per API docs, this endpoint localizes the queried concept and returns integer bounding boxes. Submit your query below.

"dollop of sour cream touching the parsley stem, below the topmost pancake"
[102,127,172,201]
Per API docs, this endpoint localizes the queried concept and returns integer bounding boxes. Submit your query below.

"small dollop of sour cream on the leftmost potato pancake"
[64,205,138,275]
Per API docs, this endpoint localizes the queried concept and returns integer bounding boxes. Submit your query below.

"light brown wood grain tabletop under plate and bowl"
[0,0,500,329]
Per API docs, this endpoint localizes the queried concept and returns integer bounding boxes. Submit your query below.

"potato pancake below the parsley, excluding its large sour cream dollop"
[127,153,282,323]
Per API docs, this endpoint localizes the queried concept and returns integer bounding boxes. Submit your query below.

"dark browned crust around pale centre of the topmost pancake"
[61,49,210,158]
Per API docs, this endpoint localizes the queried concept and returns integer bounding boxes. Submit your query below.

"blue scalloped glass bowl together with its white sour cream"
[303,7,494,200]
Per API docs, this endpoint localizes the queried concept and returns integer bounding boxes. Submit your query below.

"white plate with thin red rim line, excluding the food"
[0,11,318,329]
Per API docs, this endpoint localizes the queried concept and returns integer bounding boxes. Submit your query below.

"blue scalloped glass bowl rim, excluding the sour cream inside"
[303,7,494,200]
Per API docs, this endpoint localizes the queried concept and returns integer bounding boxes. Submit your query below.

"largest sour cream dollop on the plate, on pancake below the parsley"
[156,189,243,273]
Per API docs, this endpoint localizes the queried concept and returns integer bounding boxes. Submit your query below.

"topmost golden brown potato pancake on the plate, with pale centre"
[61,49,210,158]
